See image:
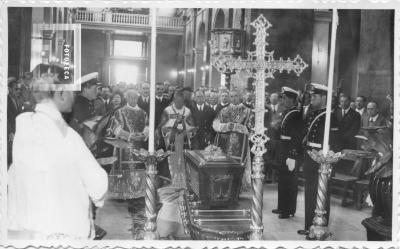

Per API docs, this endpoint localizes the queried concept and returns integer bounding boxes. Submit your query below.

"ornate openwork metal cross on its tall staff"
[212,14,308,240]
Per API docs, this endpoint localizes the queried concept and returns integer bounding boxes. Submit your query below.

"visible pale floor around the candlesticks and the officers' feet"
[96,184,372,241]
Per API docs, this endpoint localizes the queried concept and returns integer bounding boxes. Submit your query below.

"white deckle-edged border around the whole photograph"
[0,0,400,248]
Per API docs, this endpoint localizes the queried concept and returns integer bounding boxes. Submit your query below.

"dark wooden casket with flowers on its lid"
[184,150,245,209]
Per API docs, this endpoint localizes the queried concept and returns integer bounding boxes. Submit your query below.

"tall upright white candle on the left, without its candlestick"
[149,8,157,154]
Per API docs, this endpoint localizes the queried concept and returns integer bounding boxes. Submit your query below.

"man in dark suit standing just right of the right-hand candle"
[336,95,361,150]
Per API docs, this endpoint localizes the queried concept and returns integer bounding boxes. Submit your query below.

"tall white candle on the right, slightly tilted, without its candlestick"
[322,9,338,155]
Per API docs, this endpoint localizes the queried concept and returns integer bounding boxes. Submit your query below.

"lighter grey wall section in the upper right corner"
[357,10,394,104]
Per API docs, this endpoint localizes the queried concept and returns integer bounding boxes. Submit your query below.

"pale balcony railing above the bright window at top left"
[74,10,184,30]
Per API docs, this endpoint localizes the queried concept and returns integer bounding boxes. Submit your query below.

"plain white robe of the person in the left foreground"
[8,102,108,239]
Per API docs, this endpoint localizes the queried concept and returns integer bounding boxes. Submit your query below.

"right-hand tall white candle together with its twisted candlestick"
[308,9,341,240]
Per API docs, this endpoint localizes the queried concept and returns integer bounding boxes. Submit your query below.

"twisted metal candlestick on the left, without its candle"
[132,149,170,240]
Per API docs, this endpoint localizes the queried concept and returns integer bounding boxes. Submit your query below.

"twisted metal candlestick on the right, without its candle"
[308,150,343,240]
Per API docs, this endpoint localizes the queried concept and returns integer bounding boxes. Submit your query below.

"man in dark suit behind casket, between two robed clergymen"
[191,90,215,150]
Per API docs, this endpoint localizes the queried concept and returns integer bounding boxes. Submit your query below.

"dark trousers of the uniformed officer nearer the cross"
[278,171,297,215]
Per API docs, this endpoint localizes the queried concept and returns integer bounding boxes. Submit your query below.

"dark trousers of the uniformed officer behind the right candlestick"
[303,153,330,230]
